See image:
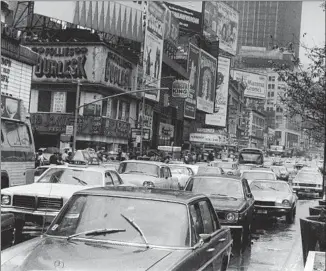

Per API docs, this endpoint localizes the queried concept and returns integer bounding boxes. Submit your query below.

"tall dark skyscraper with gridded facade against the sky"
[226,1,302,57]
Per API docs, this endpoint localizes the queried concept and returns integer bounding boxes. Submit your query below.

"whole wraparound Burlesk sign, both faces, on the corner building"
[32,43,137,91]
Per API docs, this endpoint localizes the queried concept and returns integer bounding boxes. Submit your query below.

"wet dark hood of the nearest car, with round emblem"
[1,237,184,271]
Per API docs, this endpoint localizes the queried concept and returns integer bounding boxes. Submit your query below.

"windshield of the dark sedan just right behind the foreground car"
[189,177,243,198]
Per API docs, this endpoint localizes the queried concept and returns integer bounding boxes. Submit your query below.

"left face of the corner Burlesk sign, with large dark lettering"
[32,47,88,79]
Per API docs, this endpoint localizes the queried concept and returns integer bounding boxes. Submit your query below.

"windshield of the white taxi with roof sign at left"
[37,168,103,186]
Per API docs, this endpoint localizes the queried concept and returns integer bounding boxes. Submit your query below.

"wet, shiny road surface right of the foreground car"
[228,200,318,271]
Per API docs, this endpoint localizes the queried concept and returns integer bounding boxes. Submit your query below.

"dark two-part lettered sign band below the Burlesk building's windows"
[31,113,130,139]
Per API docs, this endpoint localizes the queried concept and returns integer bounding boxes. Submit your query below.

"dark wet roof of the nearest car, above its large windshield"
[75,186,207,204]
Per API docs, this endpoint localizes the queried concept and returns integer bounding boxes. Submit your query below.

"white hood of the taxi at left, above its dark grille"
[1,183,93,202]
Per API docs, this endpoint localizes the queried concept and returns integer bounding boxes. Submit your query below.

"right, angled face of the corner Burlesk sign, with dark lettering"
[104,52,132,90]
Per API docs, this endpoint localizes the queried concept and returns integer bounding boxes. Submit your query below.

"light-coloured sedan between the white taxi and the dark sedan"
[118,160,180,190]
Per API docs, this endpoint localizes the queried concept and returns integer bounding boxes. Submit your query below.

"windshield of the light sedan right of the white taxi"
[119,162,159,177]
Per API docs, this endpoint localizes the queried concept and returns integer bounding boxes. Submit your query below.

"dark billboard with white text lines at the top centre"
[164,2,202,33]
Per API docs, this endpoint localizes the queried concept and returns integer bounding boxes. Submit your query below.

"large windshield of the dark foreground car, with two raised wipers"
[47,195,190,247]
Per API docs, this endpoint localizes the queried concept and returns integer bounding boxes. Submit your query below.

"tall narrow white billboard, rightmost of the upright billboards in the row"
[205,56,230,127]
